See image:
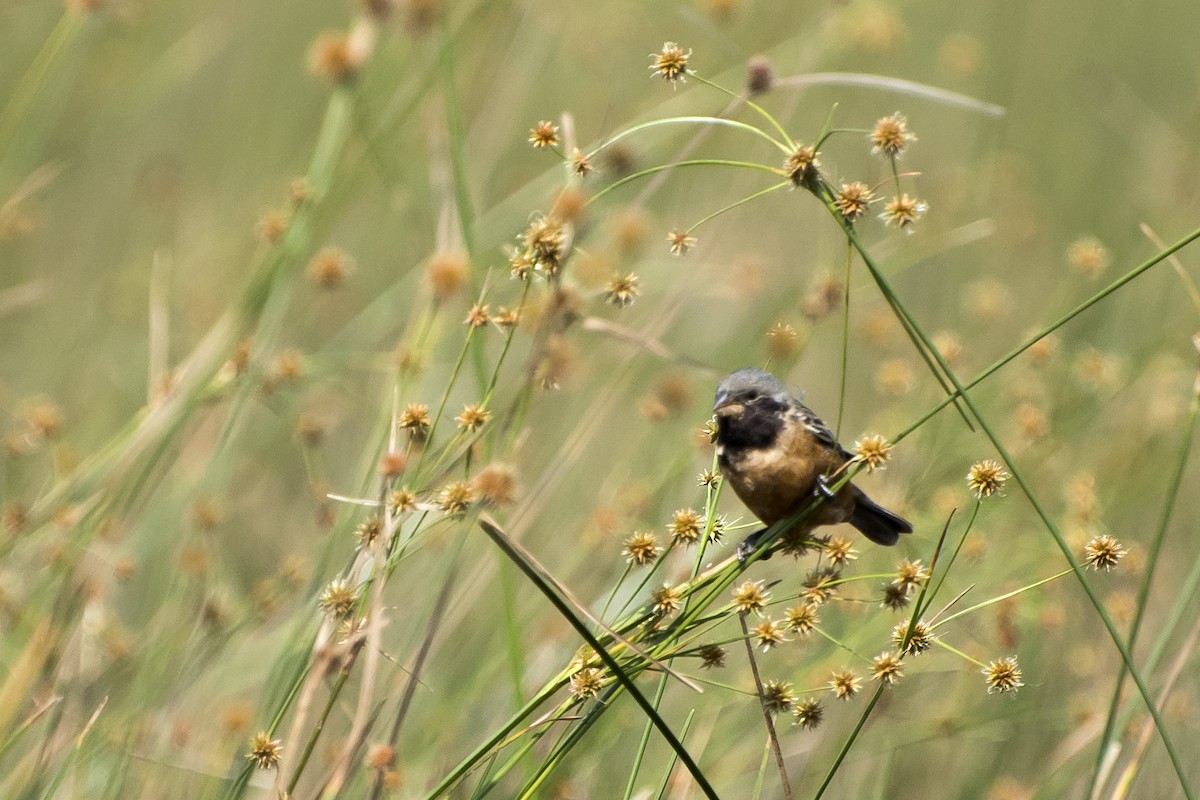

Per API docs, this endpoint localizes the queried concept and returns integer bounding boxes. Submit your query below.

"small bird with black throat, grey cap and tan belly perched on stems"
[713,369,912,559]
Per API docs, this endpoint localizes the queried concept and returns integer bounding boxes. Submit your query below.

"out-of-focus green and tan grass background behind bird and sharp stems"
[0,0,1200,800]
